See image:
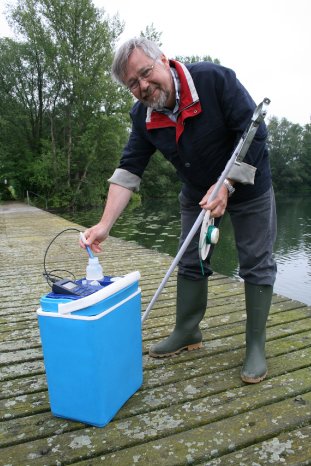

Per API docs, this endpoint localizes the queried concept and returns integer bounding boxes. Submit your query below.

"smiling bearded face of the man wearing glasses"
[125,48,175,110]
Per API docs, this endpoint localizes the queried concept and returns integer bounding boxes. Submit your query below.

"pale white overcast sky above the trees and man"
[0,0,311,125]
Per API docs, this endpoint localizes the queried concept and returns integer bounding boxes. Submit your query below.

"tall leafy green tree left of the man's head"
[0,0,132,206]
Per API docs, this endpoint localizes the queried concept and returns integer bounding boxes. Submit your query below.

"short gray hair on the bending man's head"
[112,36,163,84]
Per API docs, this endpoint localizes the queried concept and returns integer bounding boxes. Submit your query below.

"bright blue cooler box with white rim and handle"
[37,272,143,427]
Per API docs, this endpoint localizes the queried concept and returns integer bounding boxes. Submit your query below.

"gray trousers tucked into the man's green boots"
[178,188,277,285]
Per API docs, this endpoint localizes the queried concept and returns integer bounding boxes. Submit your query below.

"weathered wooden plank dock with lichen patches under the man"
[0,203,311,466]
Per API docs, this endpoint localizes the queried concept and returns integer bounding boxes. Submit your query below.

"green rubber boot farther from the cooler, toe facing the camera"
[241,282,273,383]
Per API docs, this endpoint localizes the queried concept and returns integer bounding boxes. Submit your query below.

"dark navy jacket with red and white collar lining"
[119,60,271,203]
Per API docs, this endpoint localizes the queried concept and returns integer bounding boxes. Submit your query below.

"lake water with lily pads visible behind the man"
[59,197,311,305]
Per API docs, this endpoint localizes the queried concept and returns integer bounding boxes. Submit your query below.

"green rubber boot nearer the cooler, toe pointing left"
[149,275,207,358]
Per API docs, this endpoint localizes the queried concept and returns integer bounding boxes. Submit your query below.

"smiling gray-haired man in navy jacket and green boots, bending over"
[81,37,276,383]
